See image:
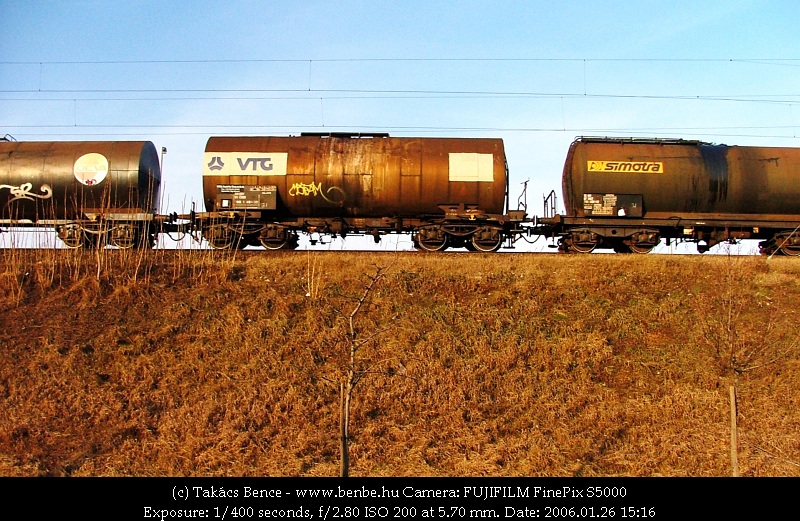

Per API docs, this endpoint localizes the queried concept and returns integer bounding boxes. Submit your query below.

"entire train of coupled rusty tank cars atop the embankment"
[0,133,800,256]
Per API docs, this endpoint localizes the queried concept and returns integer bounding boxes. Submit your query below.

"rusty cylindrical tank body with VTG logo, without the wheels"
[203,135,507,218]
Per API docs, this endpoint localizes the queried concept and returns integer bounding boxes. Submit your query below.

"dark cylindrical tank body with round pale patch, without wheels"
[0,141,161,223]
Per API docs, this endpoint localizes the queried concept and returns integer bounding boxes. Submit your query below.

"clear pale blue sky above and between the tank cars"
[0,0,800,250]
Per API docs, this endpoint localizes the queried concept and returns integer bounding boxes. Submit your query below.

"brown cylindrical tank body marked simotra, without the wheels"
[562,138,800,218]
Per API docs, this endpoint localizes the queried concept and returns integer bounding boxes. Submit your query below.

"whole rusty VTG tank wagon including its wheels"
[200,134,524,251]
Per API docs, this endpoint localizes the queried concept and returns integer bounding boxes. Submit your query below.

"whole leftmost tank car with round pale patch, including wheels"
[0,141,161,248]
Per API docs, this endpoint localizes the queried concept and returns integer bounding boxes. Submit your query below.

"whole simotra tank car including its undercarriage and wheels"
[541,138,800,256]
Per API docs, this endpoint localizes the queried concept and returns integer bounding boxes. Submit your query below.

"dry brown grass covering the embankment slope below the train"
[0,250,800,476]
